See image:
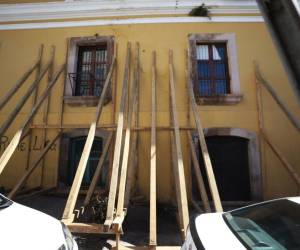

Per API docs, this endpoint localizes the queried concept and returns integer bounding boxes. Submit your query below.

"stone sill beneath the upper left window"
[64,96,110,107]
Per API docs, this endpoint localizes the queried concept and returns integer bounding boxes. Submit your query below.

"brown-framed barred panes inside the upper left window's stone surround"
[75,45,108,96]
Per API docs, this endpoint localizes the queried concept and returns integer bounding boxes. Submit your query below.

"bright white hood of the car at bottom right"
[195,213,246,250]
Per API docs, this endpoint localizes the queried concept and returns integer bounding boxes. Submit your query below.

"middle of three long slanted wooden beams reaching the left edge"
[0,56,52,136]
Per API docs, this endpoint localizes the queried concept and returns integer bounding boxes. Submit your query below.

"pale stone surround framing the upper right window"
[188,33,243,105]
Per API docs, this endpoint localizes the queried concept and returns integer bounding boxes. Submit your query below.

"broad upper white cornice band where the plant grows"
[0,0,259,22]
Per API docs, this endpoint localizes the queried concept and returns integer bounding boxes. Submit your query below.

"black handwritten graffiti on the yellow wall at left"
[0,135,56,152]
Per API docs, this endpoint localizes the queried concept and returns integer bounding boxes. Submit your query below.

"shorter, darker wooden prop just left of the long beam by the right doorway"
[187,131,211,213]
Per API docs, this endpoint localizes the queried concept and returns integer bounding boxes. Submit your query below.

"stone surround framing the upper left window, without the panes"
[64,36,115,107]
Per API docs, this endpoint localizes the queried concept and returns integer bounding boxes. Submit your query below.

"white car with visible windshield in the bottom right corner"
[181,197,300,250]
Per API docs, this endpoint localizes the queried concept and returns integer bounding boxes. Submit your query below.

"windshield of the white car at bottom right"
[223,200,300,250]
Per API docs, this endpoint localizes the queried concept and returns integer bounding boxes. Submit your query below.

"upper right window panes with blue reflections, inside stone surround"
[195,43,230,96]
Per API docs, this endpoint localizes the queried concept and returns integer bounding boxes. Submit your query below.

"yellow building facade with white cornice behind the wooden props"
[0,1,300,206]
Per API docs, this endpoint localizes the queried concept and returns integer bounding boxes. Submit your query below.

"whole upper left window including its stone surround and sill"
[64,34,114,107]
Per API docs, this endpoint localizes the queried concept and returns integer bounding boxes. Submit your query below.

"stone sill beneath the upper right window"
[196,94,243,105]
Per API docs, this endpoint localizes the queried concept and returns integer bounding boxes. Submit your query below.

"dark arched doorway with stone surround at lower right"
[193,128,262,201]
